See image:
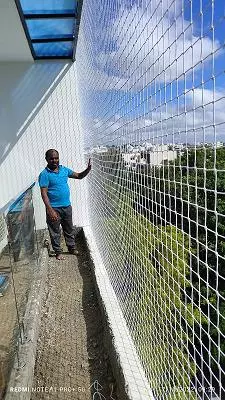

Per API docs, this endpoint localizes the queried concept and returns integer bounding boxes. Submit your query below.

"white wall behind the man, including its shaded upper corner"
[0,62,87,228]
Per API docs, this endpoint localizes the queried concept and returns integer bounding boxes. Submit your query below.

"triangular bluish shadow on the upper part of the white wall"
[0,61,71,165]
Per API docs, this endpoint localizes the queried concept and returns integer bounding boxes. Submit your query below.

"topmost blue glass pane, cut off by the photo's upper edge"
[20,0,77,14]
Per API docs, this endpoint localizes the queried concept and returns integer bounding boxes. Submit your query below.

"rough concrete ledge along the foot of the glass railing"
[5,249,48,400]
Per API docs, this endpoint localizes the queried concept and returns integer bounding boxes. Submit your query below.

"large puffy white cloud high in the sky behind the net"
[90,0,220,90]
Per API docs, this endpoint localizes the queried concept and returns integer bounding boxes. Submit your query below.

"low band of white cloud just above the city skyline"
[87,89,225,145]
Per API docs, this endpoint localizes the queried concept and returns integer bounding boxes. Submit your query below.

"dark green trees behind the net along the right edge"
[135,148,225,386]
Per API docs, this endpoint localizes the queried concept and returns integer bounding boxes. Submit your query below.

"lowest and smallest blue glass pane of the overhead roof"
[33,42,73,57]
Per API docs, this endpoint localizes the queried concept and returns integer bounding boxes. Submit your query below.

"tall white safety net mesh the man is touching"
[76,0,225,400]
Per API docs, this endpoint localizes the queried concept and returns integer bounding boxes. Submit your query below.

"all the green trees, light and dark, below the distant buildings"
[97,148,225,400]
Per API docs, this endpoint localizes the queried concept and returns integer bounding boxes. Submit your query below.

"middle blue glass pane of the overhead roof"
[26,18,76,40]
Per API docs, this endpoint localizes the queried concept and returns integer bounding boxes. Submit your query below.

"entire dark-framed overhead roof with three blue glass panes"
[15,0,82,59]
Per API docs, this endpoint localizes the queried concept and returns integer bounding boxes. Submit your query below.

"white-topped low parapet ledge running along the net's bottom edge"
[84,226,154,400]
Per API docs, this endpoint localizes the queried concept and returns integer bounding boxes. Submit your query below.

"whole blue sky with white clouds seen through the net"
[77,0,225,148]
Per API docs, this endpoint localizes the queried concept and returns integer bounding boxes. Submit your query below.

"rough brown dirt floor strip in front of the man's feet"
[31,232,118,400]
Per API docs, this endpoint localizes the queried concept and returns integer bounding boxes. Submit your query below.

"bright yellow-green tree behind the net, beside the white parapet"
[105,191,200,400]
